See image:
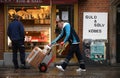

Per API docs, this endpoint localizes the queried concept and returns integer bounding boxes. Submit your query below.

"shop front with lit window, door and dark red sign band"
[1,0,78,65]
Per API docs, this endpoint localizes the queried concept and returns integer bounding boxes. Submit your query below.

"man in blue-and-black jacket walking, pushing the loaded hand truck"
[51,20,86,71]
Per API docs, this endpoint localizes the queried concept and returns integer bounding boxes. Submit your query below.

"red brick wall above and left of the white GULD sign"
[78,0,110,48]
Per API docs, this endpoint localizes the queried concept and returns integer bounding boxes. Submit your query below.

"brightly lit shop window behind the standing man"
[7,6,51,50]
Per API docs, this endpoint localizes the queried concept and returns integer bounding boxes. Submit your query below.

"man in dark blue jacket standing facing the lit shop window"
[7,15,26,69]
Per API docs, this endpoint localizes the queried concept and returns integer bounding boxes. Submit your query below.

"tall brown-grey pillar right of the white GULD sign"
[108,0,120,65]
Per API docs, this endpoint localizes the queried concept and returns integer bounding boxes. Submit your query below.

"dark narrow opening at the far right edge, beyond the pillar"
[116,5,120,63]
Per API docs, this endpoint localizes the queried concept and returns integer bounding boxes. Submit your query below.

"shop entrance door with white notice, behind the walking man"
[56,5,76,65]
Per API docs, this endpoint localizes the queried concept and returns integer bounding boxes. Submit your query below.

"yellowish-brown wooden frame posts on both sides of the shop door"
[51,3,78,61]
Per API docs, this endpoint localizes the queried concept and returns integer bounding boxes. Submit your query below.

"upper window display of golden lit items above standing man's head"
[8,6,50,24]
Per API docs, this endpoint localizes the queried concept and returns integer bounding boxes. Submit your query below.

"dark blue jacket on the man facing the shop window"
[7,20,25,41]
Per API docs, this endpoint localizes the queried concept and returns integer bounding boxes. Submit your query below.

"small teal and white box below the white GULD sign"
[90,42,106,60]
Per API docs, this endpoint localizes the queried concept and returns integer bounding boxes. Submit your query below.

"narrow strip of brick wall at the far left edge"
[0,4,5,60]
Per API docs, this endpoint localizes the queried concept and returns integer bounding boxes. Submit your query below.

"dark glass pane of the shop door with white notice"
[56,5,74,57]
